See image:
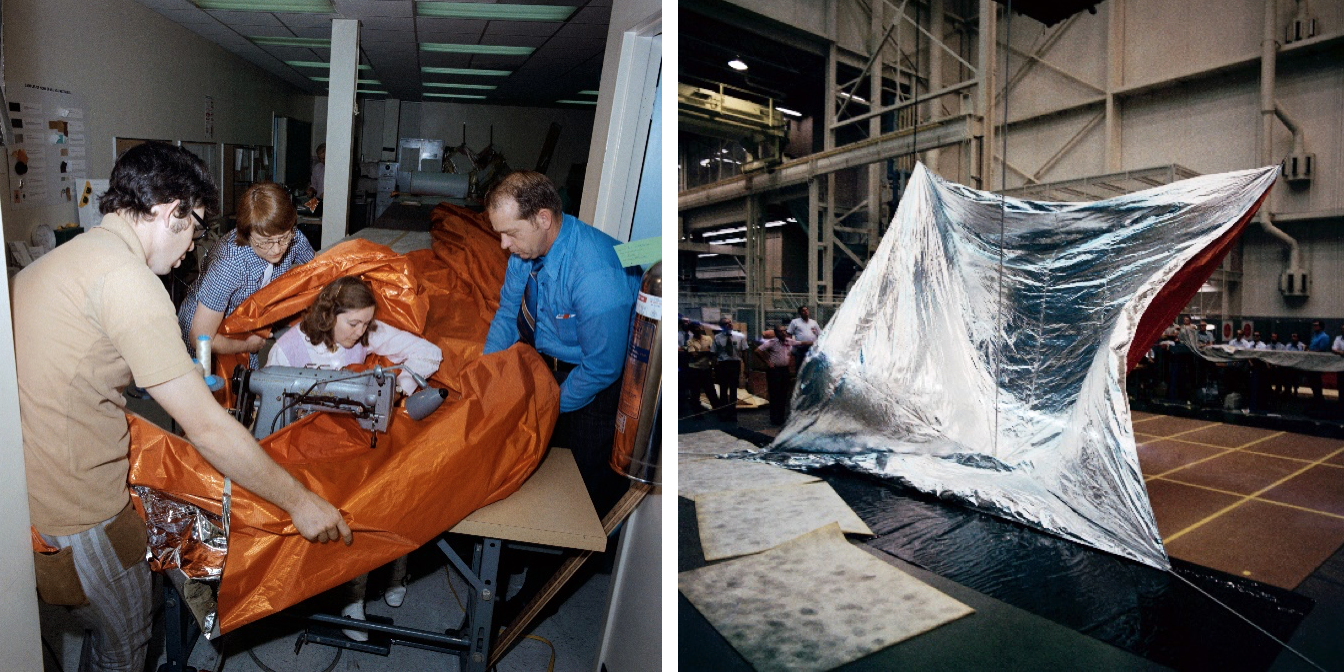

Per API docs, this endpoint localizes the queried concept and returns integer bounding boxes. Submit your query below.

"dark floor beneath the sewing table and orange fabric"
[34,399,610,672]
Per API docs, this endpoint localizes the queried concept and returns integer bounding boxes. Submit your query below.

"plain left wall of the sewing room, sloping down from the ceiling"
[0,0,312,239]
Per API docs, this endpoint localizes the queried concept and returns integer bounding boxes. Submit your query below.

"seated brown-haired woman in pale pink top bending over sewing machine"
[266,277,444,641]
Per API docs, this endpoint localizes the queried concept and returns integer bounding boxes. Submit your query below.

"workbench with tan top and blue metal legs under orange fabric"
[159,448,606,672]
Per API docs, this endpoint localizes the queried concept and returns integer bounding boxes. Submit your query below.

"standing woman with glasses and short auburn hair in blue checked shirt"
[177,181,313,368]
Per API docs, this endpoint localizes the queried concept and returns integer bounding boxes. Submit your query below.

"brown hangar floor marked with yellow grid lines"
[679,407,1344,671]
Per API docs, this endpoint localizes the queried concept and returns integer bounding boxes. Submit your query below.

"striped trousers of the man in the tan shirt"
[42,510,153,672]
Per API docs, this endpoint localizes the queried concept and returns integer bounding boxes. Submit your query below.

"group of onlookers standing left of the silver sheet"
[677,306,821,425]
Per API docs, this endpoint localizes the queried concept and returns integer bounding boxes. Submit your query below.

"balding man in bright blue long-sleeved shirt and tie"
[485,171,640,516]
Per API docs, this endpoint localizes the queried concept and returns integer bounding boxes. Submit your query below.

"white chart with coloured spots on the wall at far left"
[7,83,89,208]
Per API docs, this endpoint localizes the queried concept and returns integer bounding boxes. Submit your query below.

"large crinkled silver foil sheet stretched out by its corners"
[762,165,1277,570]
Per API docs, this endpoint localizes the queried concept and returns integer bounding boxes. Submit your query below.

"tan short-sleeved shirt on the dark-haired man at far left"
[13,215,195,535]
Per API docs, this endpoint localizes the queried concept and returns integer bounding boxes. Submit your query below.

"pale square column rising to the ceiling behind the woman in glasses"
[323,19,359,250]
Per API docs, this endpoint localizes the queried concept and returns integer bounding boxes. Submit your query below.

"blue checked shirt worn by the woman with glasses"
[177,230,313,349]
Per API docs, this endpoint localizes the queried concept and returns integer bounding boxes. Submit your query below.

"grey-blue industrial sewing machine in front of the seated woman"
[231,367,396,438]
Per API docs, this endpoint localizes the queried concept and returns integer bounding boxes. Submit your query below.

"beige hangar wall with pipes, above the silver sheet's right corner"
[995,0,1344,320]
